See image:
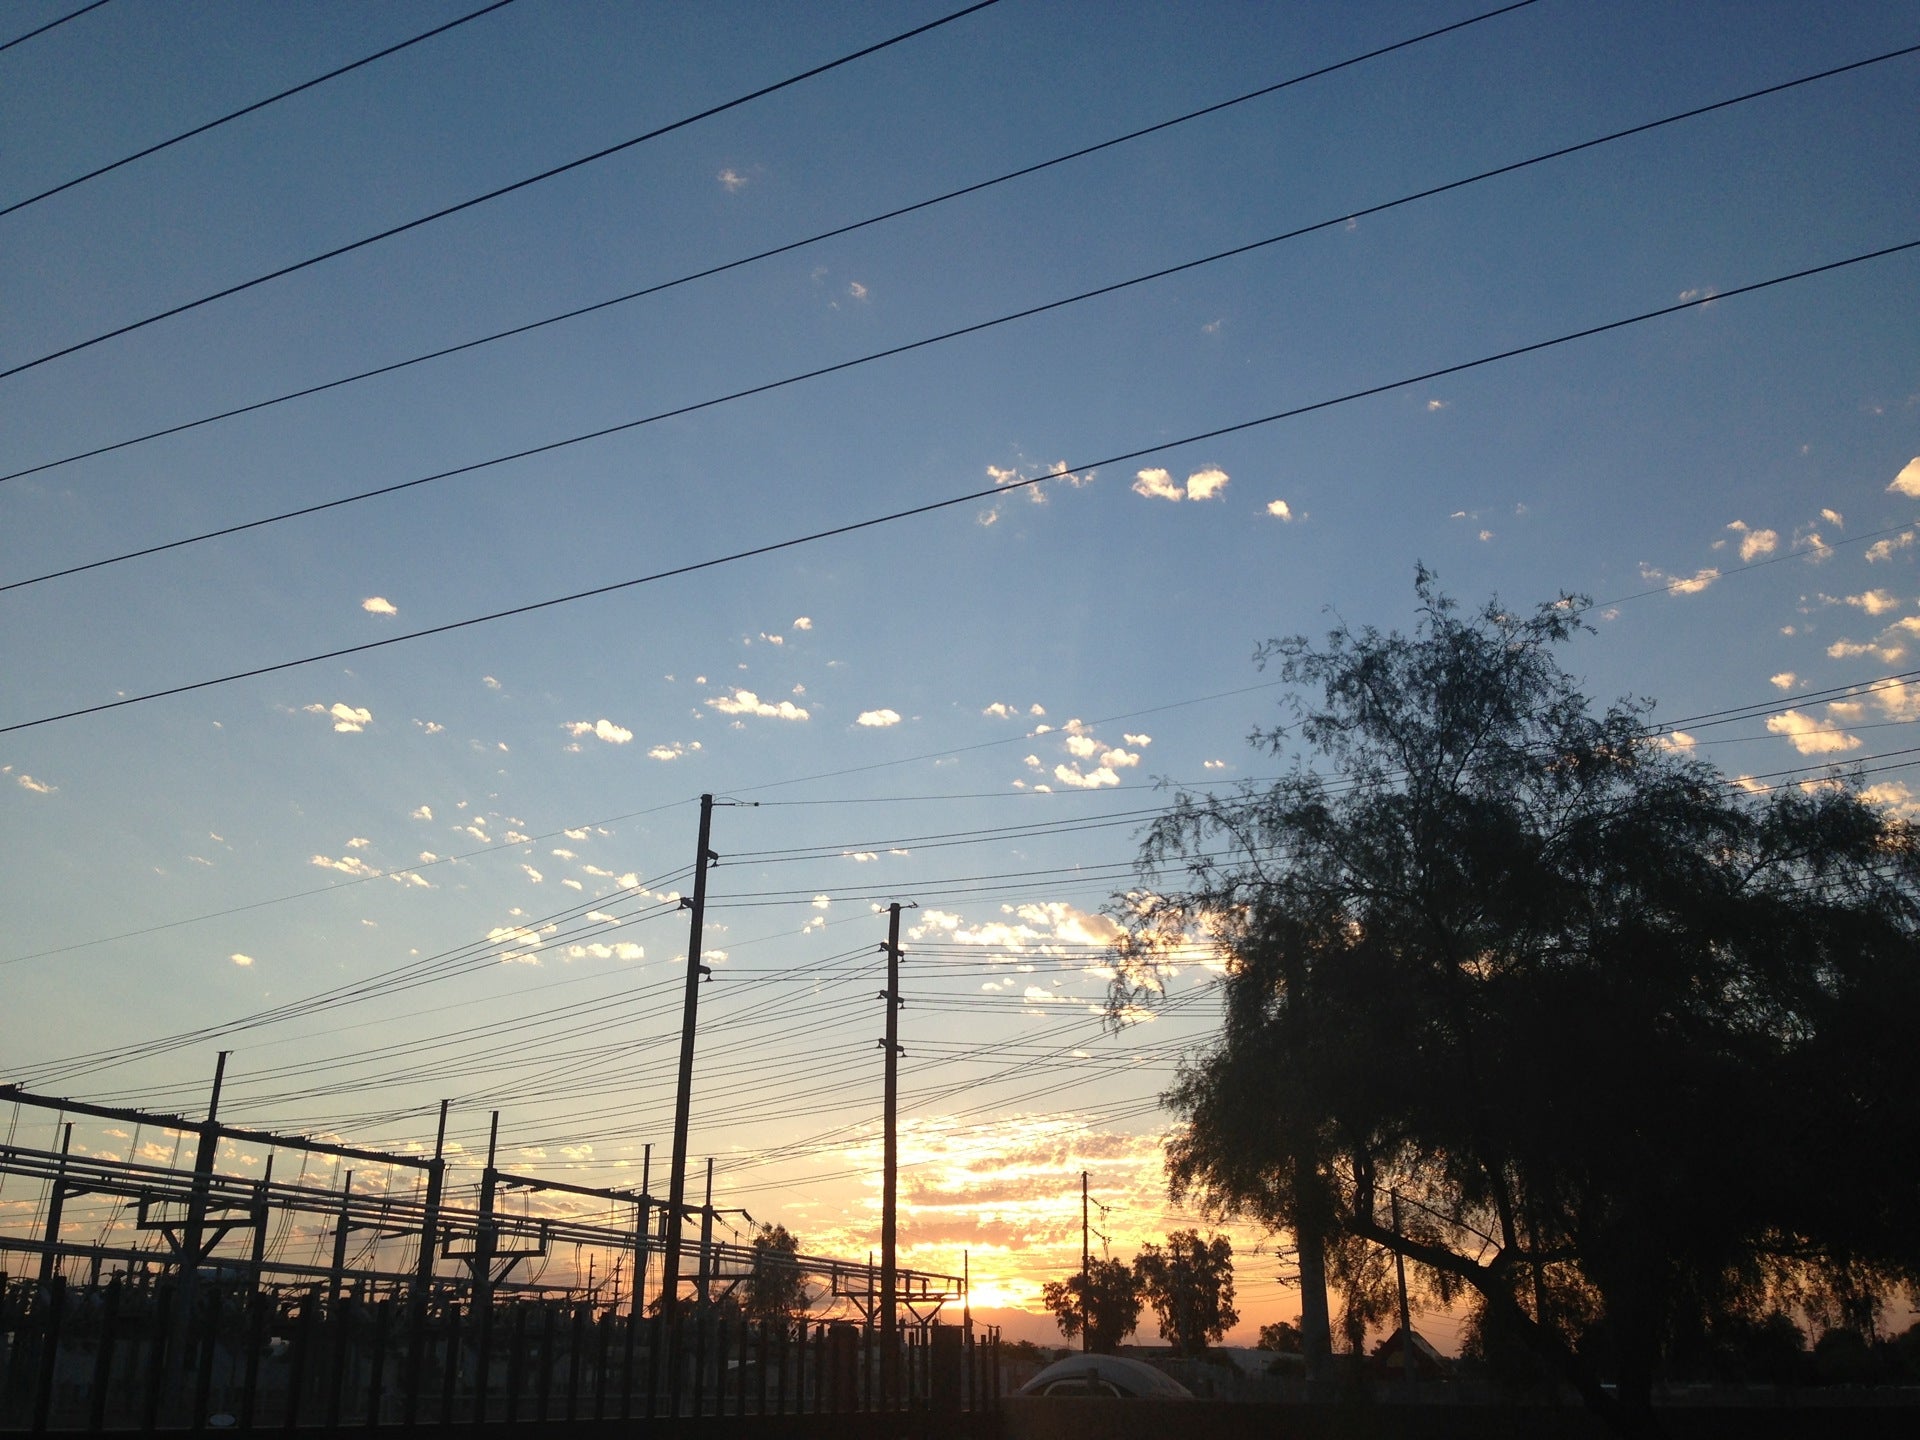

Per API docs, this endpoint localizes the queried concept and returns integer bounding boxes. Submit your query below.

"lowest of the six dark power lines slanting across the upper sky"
[0,240,1920,735]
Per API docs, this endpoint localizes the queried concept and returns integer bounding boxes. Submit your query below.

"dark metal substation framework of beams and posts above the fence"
[0,1085,966,1323]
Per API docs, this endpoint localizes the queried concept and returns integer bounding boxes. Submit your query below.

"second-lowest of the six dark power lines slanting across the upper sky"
[15,44,1920,591]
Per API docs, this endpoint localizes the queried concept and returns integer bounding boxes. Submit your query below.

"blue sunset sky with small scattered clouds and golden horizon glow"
[0,0,1920,1340]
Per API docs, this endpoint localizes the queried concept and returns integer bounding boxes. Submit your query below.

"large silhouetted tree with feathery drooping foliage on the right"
[1112,570,1920,1428]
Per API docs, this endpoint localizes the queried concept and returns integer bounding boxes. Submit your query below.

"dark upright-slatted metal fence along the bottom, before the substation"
[0,1275,1000,1432]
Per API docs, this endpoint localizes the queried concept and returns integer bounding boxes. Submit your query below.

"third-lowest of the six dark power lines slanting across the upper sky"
[0,0,1536,482]
